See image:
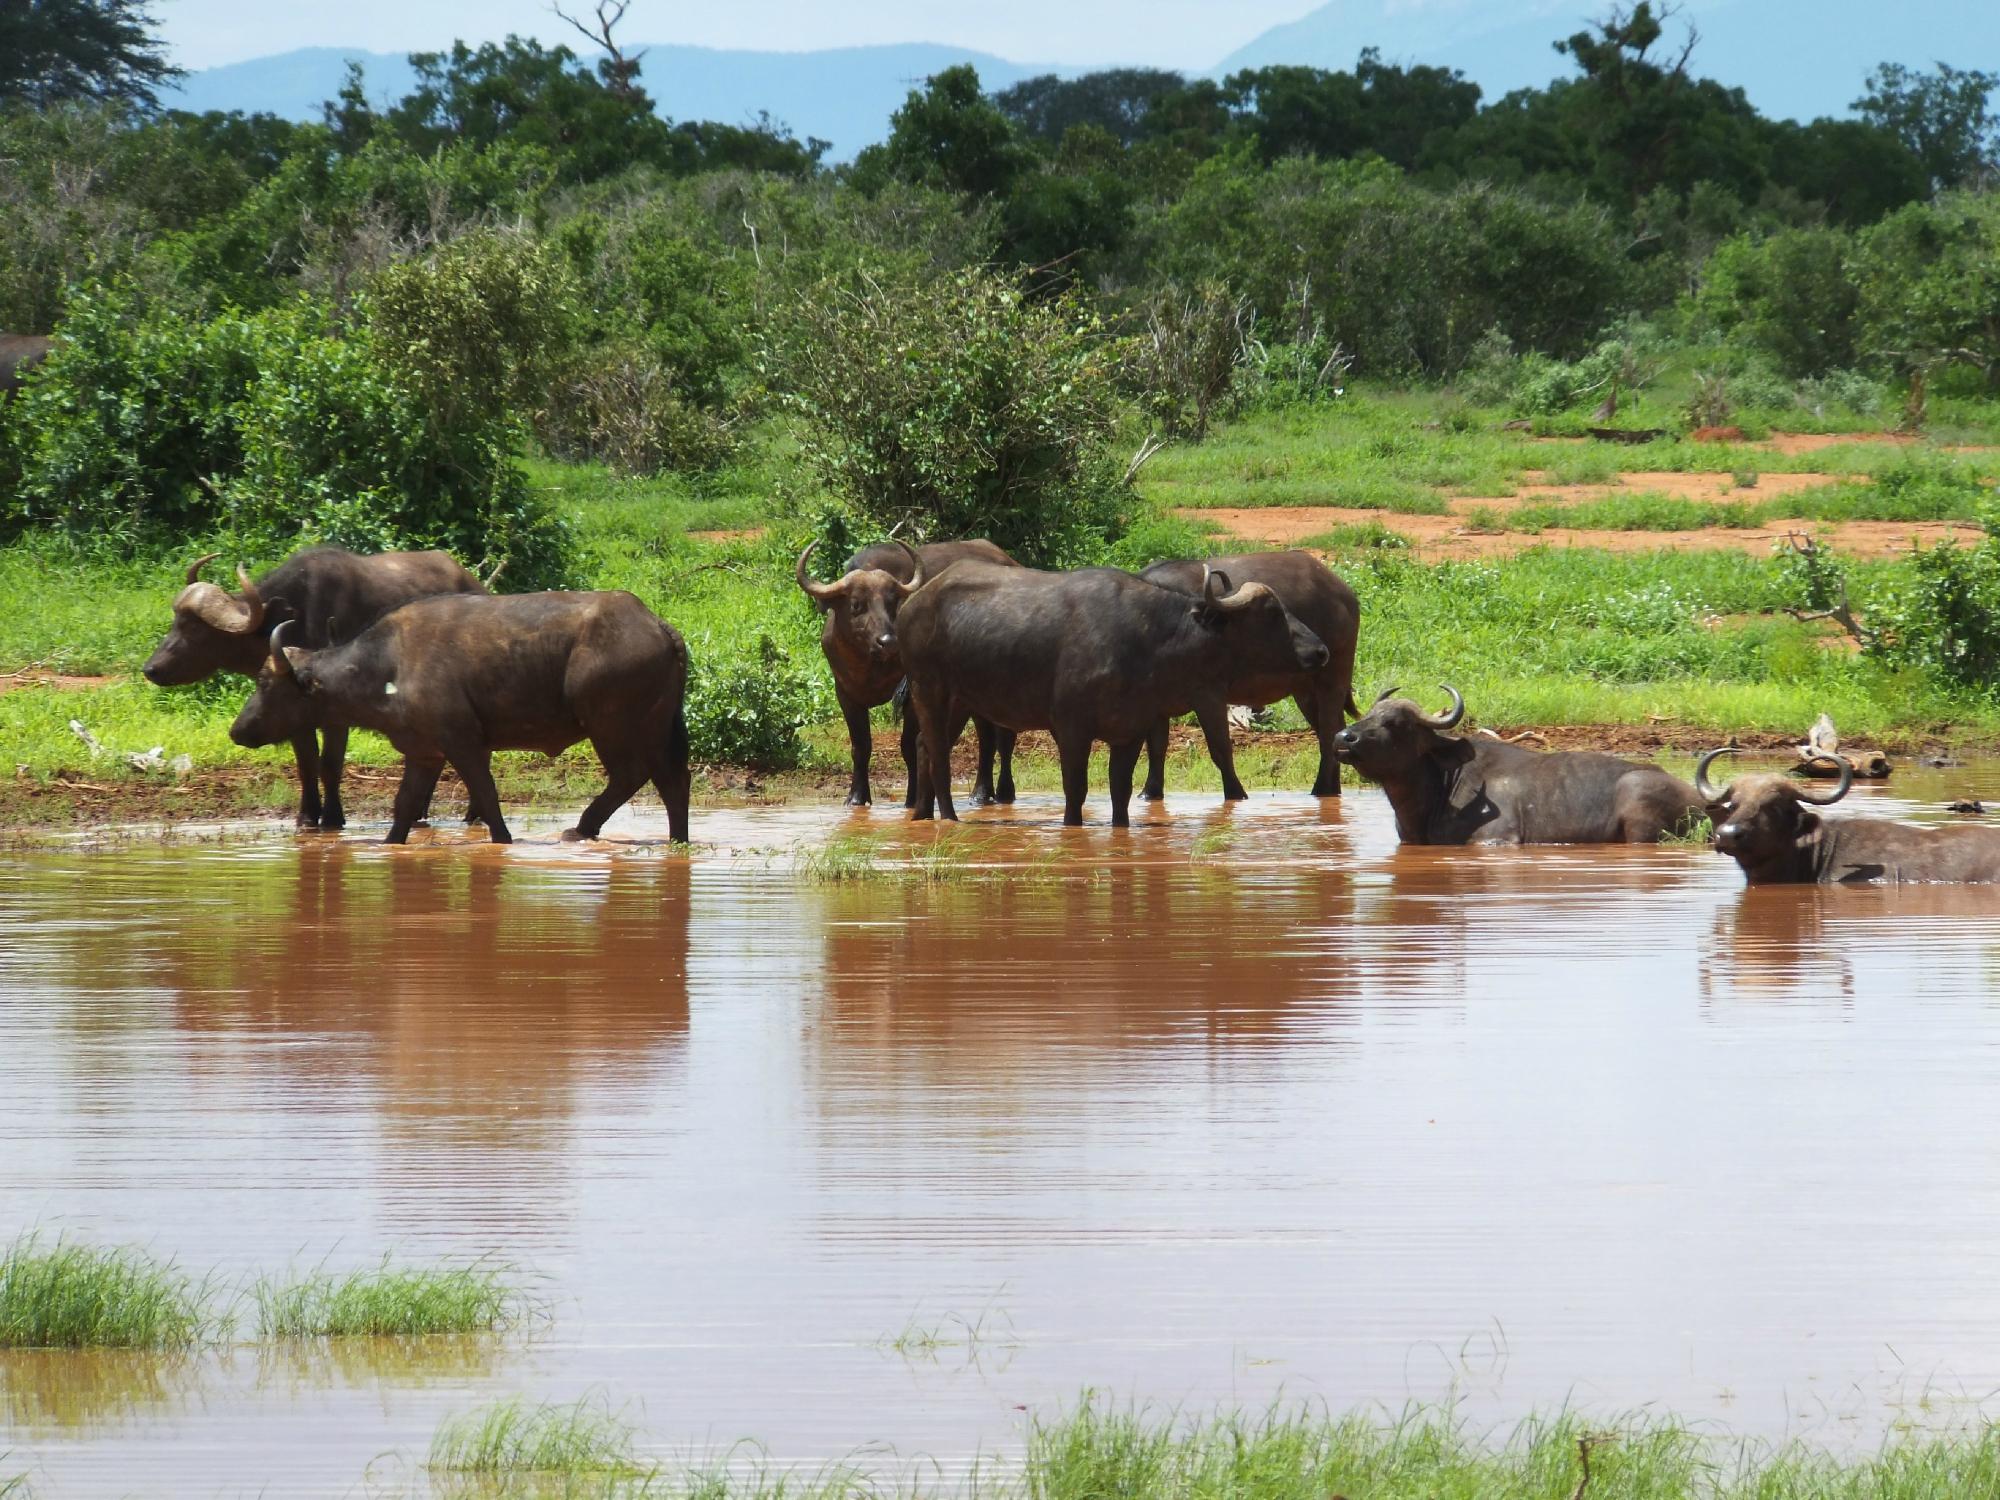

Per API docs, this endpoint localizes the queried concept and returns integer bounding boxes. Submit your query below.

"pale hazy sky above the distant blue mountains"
[158,0,1318,68]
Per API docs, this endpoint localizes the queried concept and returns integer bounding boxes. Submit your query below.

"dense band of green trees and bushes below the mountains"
[0,0,2000,584]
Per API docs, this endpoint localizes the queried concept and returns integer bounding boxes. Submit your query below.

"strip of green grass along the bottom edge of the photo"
[410,1396,2000,1500]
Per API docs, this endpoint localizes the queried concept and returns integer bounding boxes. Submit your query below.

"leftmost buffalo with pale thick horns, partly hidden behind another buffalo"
[144,546,486,828]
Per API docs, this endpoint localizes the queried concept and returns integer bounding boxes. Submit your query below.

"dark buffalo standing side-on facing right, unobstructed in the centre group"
[898,562,1328,828]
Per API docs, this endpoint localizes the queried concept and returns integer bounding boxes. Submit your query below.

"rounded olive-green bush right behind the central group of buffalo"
[770,270,1126,564]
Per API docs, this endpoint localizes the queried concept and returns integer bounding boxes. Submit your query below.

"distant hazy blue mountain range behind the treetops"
[172,0,2000,160]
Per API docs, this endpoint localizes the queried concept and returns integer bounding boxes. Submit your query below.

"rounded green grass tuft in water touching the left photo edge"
[0,1234,226,1348]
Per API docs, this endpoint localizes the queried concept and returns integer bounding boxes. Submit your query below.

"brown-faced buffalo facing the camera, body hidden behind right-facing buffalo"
[794,540,1018,808]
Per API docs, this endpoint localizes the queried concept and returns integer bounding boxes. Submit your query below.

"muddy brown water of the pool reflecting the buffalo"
[11,766,2000,1496]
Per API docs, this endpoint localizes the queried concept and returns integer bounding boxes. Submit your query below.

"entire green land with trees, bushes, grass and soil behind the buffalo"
[0,4,2000,824]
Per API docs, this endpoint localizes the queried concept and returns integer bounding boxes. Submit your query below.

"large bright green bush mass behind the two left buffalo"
[0,252,574,588]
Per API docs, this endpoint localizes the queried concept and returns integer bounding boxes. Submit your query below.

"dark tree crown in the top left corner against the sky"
[0,0,180,110]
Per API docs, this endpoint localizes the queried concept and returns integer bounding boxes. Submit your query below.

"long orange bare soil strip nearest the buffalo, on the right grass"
[1176,500,1984,562]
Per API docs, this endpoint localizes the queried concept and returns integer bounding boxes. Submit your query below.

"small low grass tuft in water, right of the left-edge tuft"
[250,1260,536,1338]
